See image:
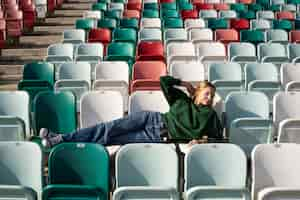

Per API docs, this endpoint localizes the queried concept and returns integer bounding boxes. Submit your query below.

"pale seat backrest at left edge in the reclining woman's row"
[0,91,30,136]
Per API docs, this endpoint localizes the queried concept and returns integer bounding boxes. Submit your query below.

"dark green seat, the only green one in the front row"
[43,143,110,200]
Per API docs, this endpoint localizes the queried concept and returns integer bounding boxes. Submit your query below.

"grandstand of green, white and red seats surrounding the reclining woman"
[0,0,300,200]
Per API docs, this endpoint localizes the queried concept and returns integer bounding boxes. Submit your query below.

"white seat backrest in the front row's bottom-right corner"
[251,144,300,200]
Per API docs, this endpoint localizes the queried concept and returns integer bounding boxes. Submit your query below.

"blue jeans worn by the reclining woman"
[62,111,163,145]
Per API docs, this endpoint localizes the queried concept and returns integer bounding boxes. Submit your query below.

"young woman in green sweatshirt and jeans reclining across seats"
[40,76,223,147]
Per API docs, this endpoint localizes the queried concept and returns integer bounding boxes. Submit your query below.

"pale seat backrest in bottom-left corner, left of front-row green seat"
[0,142,43,199]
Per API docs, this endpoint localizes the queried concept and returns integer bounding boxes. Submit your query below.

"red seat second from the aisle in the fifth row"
[88,28,111,56]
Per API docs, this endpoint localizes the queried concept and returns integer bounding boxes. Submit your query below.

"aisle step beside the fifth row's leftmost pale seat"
[19,35,62,47]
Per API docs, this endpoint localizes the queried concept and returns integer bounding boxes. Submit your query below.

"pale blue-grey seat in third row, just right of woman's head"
[208,62,244,101]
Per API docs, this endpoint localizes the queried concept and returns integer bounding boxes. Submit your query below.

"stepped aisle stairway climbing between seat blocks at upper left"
[0,0,95,90]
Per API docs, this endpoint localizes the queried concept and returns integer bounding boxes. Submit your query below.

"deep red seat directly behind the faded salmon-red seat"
[136,41,165,61]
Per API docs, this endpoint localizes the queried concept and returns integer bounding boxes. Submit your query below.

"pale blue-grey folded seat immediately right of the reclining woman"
[225,92,273,157]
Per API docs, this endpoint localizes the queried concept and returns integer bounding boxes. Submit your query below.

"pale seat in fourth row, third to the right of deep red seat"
[227,42,257,62]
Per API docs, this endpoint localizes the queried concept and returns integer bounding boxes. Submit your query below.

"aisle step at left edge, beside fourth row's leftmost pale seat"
[1,48,47,57]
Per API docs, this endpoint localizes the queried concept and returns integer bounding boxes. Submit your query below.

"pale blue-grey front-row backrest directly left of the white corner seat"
[184,144,247,191]
